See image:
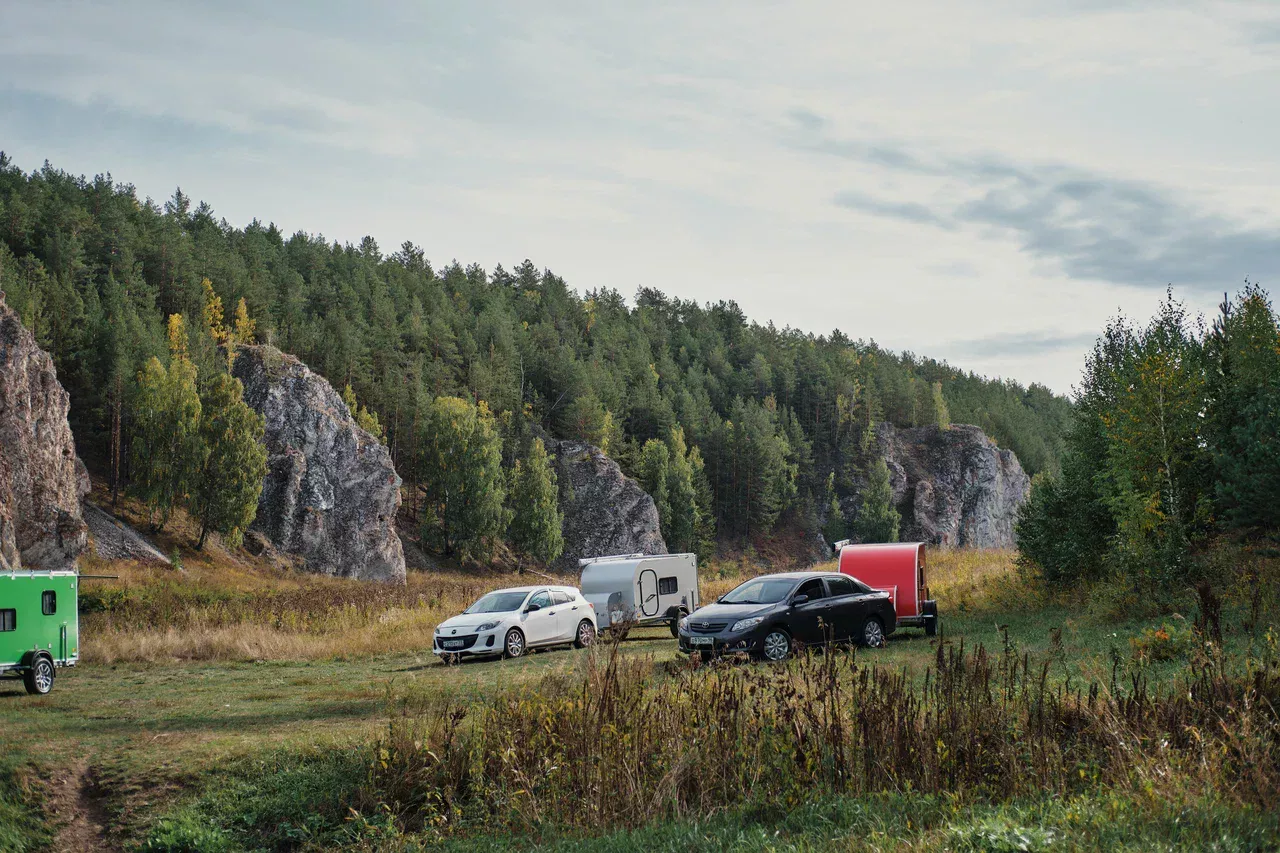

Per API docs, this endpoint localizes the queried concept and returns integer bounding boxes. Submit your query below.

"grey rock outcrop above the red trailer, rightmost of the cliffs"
[860,424,1030,548]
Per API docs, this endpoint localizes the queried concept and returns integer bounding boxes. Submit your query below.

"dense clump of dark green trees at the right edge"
[1018,283,1280,598]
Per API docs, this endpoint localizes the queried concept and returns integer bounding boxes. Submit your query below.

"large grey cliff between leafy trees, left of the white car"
[233,347,404,583]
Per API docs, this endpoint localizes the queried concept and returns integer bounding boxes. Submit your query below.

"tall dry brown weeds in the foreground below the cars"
[361,627,1280,835]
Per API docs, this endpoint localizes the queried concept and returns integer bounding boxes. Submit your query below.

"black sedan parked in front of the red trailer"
[680,571,896,661]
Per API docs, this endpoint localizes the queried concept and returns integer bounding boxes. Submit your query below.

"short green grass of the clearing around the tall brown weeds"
[0,548,1280,852]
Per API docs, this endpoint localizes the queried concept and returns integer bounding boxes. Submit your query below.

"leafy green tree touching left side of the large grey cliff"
[191,373,266,548]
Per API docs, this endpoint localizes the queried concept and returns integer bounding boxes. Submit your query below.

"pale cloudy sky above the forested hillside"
[0,0,1280,393]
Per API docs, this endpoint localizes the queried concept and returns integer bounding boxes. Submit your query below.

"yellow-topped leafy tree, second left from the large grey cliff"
[132,356,205,528]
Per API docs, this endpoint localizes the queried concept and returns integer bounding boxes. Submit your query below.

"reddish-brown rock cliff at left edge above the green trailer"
[0,293,88,570]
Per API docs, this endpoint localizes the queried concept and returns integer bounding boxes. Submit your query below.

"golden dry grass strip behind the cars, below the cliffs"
[82,540,1021,663]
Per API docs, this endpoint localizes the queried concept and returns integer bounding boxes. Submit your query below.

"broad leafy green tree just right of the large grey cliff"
[420,397,508,560]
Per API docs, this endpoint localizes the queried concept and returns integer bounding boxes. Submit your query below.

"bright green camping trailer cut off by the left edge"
[0,570,79,694]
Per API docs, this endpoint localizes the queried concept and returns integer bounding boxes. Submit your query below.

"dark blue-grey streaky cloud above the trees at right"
[801,131,1280,292]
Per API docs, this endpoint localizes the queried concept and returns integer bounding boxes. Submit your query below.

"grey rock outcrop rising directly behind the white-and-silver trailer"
[548,441,667,573]
